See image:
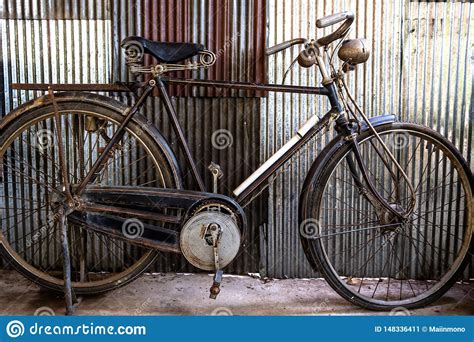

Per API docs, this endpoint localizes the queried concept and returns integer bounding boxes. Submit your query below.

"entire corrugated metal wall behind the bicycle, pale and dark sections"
[0,0,474,277]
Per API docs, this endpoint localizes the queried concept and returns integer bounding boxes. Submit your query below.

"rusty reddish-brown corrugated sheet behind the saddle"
[112,0,266,97]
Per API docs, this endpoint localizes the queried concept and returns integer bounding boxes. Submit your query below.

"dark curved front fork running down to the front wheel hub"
[336,115,406,222]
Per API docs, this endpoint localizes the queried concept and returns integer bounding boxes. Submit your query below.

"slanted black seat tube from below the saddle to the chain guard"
[155,76,206,191]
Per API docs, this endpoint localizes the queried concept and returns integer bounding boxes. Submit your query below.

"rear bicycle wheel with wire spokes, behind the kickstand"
[0,95,181,294]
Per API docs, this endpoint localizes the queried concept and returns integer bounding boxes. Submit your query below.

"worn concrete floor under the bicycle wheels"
[0,271,474,315]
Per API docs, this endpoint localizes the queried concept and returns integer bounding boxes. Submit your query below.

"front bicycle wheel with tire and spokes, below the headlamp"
[300,123,473,310]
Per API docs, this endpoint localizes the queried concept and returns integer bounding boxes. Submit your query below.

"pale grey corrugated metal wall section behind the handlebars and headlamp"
[261,0,474,278]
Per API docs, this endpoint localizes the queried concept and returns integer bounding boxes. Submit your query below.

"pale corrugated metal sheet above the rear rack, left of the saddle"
[0,1,112,115]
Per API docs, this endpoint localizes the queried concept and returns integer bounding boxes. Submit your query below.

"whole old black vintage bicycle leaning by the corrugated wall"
[0,12,473,312]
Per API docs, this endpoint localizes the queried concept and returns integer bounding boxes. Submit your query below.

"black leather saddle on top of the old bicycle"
[120,36,204,63]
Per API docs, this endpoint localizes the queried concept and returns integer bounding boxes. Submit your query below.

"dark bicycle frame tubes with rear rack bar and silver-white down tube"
[12,77,340,203]
